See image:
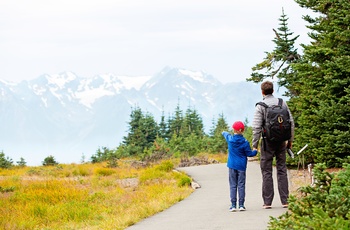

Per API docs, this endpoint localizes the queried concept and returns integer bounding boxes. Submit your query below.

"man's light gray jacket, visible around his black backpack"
[252,94,295,148]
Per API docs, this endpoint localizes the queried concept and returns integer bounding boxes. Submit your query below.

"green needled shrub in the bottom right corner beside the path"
[269,163,350,229]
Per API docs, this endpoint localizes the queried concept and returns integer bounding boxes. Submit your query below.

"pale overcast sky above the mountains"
[0,0,309,83]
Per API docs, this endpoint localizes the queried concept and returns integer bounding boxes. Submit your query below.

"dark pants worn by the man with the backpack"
[260,139,289,205]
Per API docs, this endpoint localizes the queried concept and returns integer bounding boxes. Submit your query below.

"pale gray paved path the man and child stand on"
[127,162,287,230]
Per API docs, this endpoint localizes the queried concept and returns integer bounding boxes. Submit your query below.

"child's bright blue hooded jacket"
[222,132,258,171]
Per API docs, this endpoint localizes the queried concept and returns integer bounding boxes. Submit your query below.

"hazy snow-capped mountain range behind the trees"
[0,67,284,165]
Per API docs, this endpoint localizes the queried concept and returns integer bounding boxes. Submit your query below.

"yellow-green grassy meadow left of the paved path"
[0,160,193,230]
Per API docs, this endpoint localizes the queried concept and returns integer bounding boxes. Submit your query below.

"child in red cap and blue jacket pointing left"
[222,121,258,212]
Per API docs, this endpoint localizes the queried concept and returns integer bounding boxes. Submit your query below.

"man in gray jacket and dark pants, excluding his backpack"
[252,81,294,209]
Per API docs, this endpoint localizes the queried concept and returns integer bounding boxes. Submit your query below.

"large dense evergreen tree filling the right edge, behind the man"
[291,0,350,167]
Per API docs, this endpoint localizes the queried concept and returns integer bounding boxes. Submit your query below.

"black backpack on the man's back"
[256,98,292,142]
